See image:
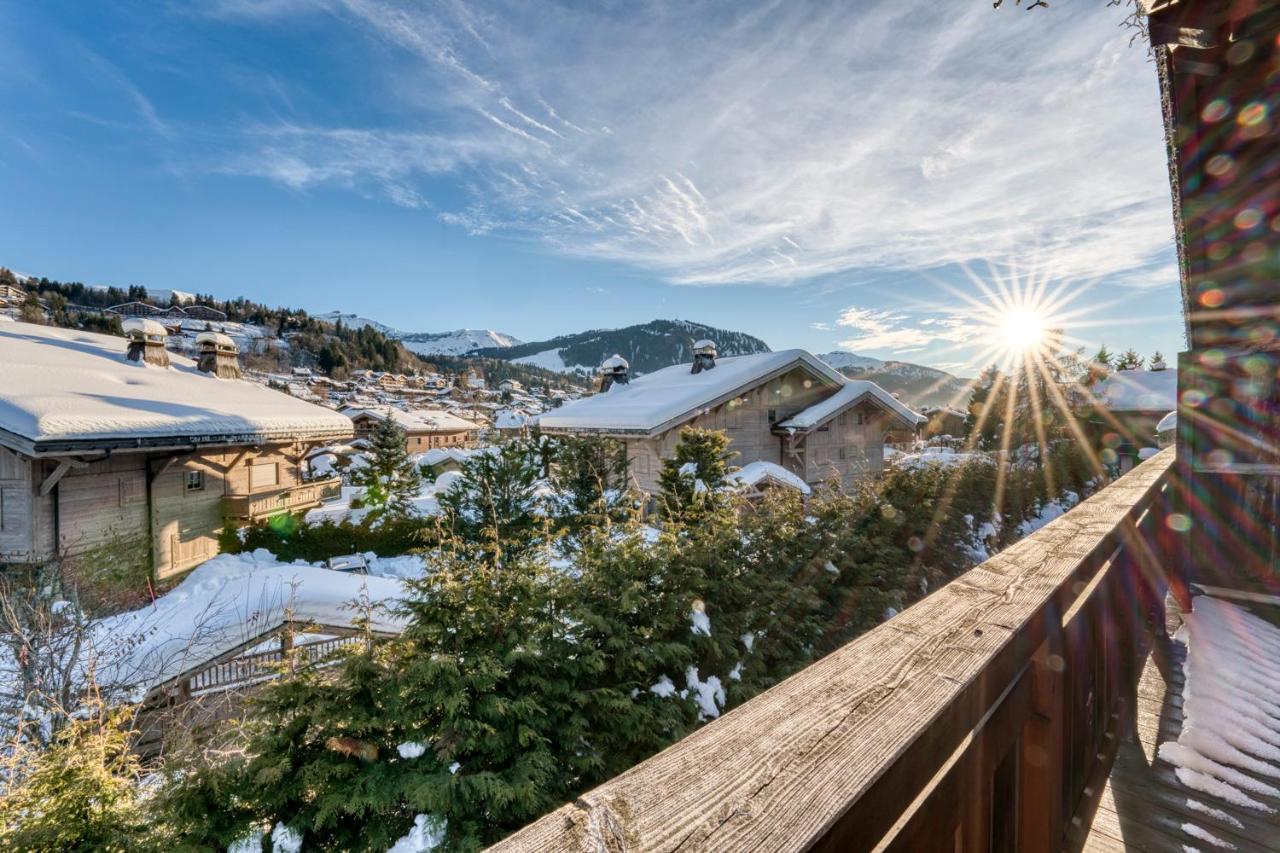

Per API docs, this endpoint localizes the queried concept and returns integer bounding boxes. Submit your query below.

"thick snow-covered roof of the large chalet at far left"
[0,323,352,453]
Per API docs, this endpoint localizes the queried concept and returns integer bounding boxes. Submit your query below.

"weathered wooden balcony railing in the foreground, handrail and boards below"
[494,450,1178,853]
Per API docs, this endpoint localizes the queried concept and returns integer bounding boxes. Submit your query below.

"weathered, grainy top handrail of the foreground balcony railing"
[493,450,1174,853]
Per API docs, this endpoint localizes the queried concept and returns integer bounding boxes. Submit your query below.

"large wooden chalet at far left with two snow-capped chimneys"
[0,318,352,580]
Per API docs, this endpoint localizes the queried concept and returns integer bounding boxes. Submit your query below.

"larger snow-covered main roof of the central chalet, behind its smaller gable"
[538,350,846,435]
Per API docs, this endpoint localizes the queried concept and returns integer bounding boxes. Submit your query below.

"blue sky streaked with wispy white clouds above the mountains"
[0,0,1181,373]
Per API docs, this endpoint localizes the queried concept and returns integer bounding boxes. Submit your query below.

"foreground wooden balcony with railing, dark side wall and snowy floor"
[494,0,1280,853]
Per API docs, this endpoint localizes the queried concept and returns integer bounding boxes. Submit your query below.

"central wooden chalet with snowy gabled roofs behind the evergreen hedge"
[538,341,920,492]
